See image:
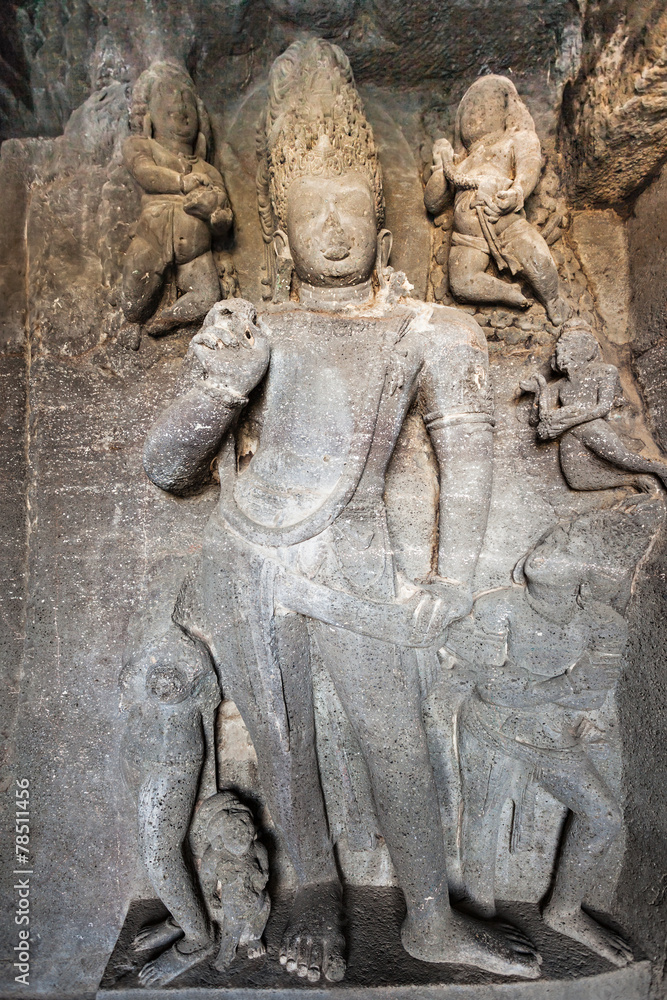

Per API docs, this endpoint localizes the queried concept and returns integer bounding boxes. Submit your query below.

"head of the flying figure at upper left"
[130,62,211,158]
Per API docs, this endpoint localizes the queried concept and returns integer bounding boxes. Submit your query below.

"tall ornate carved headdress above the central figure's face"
[257,38,384,294]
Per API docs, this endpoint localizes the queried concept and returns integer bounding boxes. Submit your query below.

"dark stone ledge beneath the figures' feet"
[97,888,651,1000]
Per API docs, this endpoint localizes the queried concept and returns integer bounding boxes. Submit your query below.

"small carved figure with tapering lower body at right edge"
[521,318,667,491]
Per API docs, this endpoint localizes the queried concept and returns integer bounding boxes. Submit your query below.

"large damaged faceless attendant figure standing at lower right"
[447,497,665,966]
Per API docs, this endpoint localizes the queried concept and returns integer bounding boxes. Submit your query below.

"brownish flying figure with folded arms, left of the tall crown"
[122,62,233,336]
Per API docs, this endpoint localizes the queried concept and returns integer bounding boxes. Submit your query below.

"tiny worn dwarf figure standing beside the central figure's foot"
[190,791,271,971]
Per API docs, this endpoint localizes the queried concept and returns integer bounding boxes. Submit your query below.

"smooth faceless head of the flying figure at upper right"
[454,75,535,153]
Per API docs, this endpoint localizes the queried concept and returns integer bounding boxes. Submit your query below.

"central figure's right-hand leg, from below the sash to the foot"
[315,624,540,978]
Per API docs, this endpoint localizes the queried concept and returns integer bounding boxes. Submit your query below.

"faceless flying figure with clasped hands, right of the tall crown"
[424,75,568,325]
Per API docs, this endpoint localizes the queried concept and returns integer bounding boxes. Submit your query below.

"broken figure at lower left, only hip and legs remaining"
[120,625,220,987]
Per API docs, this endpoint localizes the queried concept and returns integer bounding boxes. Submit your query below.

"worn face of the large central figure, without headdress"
[287,170,377,287]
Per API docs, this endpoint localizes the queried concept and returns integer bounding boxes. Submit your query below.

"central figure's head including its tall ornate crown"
[258,39,391,287]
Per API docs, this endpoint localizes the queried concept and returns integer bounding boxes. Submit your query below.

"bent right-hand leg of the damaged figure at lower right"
[540,761,633,966]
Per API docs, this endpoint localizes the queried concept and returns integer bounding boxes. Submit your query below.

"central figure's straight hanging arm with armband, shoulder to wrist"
[420,309,493,587]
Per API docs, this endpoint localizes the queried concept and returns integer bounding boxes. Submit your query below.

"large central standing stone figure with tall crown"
[144,39,540,981]
